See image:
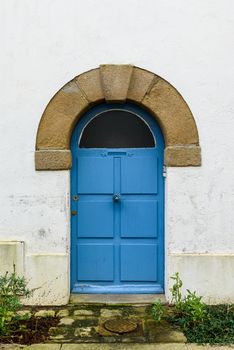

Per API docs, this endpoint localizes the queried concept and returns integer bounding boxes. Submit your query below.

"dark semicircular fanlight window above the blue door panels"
[79,110,155,148]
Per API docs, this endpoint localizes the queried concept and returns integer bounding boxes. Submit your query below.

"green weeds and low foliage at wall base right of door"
[152,273,234,344]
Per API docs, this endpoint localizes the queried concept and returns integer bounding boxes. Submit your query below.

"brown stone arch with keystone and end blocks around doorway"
[35,65,201,170]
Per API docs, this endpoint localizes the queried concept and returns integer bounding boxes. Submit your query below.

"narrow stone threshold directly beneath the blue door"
[69,294,166,305]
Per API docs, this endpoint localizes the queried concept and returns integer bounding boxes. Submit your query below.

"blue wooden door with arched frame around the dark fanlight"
[71,104,164,293]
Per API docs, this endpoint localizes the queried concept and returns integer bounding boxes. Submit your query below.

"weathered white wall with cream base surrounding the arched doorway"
[0,0,234,304]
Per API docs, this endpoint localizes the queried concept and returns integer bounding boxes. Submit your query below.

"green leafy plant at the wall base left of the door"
[0,265,31,336]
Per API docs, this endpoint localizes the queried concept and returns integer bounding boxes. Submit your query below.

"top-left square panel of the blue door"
[78,155,113,194]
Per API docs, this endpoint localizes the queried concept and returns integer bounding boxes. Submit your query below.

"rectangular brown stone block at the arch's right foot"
[164,145,201,167]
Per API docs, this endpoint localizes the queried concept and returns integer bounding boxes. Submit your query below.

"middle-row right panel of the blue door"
[121,199,158,238]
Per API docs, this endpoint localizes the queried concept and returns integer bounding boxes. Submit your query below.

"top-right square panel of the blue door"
[121,156,158,194]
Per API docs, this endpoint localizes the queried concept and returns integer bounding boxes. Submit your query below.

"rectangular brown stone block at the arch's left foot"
[35,150,72,170]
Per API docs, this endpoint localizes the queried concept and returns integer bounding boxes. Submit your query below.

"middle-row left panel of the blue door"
[77,198,114,238]
